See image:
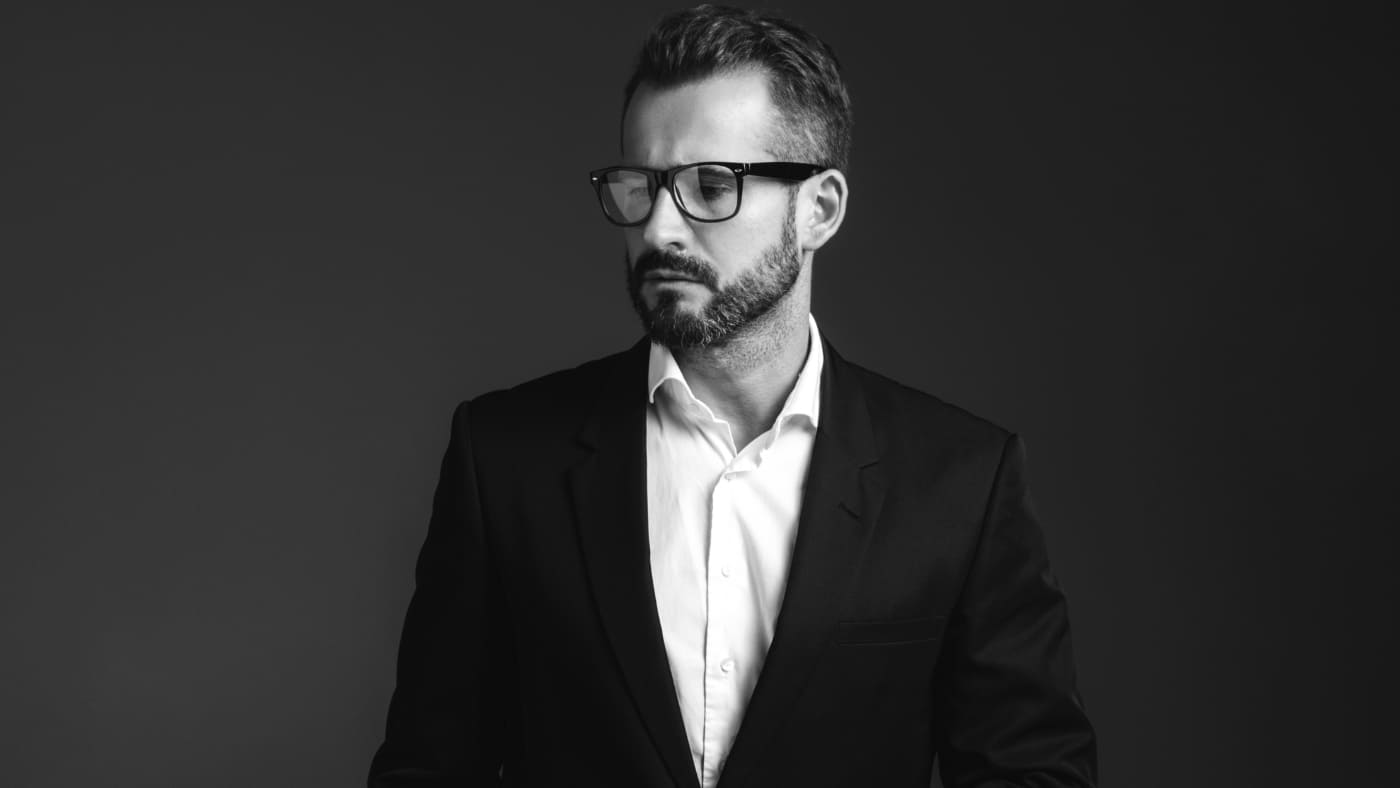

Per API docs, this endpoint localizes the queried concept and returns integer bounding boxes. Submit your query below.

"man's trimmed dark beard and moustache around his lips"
[627,206,802,350]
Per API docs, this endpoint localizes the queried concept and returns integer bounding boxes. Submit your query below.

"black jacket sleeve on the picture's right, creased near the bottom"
[934,435,1098,788]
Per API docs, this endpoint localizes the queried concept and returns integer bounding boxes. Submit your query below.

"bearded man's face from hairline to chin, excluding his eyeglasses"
[622,70,802,349]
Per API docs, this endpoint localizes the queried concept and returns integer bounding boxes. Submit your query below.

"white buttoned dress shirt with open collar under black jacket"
[647,315,823,788]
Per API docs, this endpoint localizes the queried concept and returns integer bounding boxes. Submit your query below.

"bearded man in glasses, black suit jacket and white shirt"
[370,6,1096,788]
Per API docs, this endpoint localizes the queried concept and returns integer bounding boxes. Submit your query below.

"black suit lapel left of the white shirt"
[570,340,697,788]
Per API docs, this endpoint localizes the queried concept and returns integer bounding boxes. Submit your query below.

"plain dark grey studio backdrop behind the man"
[0,1,1400,788]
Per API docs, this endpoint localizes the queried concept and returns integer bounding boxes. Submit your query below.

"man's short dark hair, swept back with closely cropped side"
[622,4,853,171]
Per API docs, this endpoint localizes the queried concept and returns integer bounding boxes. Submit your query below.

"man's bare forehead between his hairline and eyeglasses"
[622,69,778,167]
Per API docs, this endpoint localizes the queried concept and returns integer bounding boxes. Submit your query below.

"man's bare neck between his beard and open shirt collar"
[672,298,812,449]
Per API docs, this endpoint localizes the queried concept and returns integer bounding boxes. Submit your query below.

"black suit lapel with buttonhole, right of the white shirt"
[720,343,885,788]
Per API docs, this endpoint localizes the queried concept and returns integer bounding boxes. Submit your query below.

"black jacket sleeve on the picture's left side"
[370,403,514,788]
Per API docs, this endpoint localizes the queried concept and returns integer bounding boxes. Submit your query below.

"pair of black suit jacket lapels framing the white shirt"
[570,334,885,788]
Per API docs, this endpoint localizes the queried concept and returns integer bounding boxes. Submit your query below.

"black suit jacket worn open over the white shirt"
[370,342,1096,788]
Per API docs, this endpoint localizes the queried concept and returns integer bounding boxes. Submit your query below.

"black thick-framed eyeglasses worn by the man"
[588,161,825,227]
